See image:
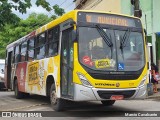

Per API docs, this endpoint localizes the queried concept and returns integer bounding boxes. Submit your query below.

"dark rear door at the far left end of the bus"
[5,51,12,89]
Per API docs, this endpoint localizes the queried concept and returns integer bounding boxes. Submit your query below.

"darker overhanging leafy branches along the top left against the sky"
[0,0,64,28]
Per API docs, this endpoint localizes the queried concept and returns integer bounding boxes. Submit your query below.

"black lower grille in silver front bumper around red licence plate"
[97,90,135,99]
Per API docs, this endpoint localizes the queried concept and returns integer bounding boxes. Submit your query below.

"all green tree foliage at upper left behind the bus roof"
[0,0,65,58]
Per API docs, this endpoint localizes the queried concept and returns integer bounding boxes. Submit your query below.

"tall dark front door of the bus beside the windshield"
[60,20,73,99]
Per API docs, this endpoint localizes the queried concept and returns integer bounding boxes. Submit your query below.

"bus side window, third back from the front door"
[28,38,35,61]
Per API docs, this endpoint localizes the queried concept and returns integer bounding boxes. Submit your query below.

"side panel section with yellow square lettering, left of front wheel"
[25,59,47,95]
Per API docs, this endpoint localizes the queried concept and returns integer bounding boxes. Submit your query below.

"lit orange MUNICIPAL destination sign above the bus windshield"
[79,13,141,27]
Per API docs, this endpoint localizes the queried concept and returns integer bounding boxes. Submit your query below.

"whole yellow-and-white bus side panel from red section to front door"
[24,56,60,97]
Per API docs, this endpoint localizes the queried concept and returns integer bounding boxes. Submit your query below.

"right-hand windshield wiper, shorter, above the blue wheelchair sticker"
[120,29,130,49]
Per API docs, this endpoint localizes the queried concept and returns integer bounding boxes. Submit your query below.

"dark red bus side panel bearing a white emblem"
[16,62,27,92]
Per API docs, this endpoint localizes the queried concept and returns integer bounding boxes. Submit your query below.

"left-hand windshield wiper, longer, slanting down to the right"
[96,25,113,47]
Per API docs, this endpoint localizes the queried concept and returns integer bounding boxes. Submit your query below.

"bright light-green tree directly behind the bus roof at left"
[0,13,52,58]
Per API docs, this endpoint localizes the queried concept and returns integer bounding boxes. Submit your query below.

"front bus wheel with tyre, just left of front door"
[50,83,65,111]
